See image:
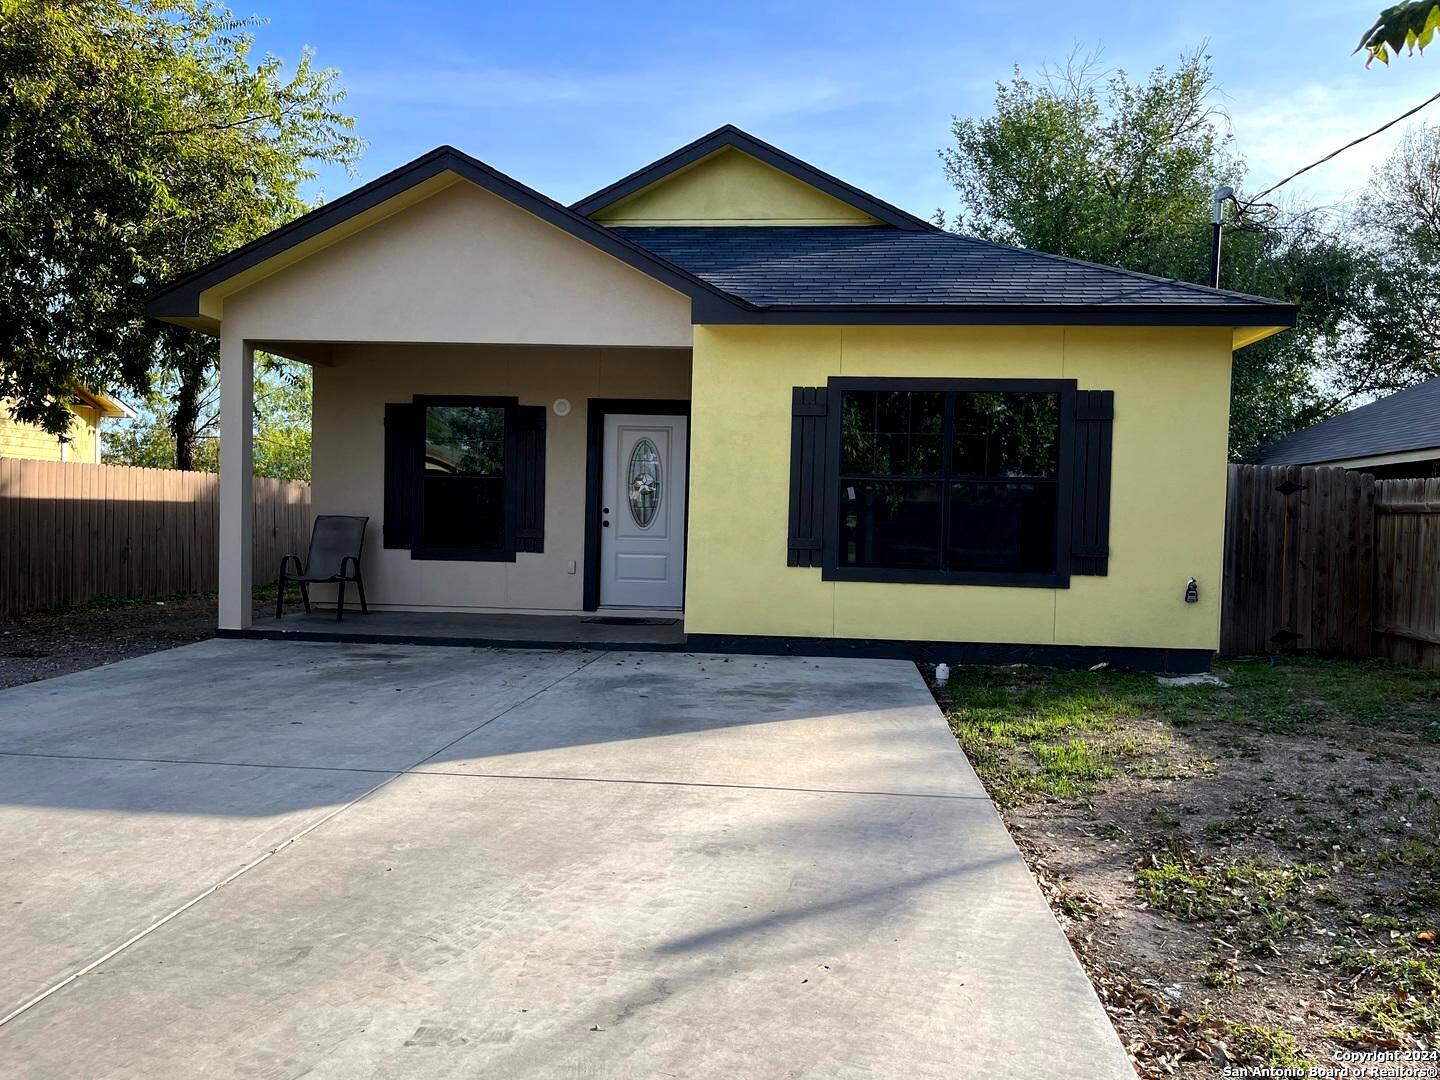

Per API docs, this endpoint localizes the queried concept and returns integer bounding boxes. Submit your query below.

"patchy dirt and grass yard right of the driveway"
[927,660,1440,1077]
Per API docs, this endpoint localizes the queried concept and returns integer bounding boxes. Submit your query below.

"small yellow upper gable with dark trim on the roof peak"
[570,124,935,232]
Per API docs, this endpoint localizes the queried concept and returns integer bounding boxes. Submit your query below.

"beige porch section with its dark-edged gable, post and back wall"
[182,160,711,629]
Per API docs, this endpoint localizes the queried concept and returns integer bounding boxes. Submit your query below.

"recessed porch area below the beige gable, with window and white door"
[220,341,691,633]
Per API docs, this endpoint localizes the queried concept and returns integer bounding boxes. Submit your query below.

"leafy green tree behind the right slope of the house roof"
[940,52,1358,455]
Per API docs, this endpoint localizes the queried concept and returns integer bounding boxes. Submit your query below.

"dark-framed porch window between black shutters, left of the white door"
[419,405,505,557]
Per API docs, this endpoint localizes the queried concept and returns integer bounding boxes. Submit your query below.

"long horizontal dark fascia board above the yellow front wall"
[694,304,1299,327]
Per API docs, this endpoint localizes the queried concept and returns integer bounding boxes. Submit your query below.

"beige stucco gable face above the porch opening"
[223,181,691,348]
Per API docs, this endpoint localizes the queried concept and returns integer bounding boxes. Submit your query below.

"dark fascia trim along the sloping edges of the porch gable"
[145,147,752,328]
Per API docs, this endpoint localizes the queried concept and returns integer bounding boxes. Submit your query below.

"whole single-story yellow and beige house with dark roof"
[150,127,1295,668]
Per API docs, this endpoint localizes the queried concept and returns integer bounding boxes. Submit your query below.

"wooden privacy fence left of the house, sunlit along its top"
[0,458,310,615]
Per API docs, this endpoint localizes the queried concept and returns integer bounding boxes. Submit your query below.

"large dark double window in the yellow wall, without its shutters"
[832,380,1067,585]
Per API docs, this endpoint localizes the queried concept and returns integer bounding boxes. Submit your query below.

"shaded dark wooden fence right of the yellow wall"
[1220,465,1440,668]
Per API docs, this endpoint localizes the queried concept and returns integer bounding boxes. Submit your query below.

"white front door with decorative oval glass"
[600,413,688,609]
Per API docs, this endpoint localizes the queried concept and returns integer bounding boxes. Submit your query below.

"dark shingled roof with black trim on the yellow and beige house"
[147,127,1296,334]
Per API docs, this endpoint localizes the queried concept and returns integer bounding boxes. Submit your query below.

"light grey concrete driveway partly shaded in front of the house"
[0,641,1133,1080]
